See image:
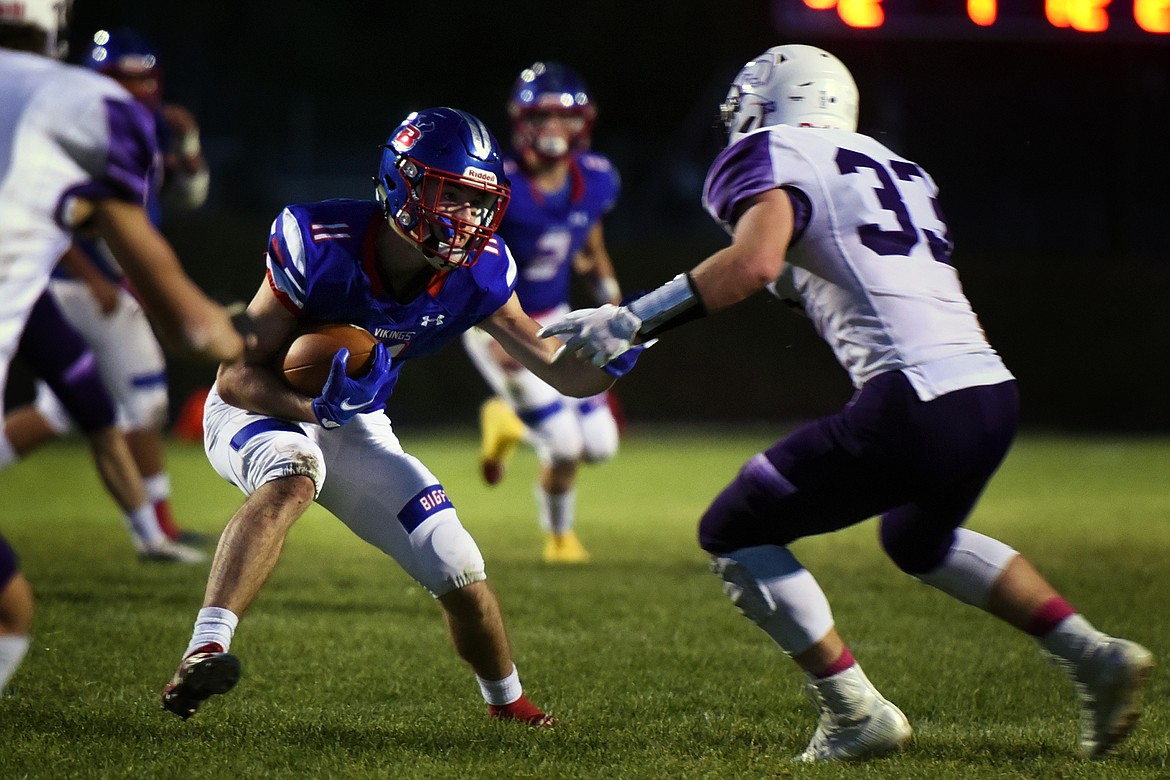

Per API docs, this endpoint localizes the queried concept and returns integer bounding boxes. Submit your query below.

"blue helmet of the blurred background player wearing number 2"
[508,62,597,159]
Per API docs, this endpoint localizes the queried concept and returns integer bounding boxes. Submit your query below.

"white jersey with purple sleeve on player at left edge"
[0,50,158,365]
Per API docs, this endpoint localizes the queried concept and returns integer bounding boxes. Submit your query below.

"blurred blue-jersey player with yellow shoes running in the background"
[463,62,621,562]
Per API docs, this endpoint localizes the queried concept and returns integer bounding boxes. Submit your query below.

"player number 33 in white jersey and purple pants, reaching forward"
[542,46,1154,761]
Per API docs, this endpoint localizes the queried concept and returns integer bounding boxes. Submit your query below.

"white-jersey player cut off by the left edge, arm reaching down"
[0,0,245,701]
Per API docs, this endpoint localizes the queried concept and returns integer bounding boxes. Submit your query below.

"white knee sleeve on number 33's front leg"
[711,545,833,655]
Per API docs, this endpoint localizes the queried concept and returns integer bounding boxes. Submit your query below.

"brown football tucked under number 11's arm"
[276,323,378,398]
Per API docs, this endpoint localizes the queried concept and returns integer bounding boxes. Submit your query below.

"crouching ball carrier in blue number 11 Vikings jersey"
[163,108,628,726]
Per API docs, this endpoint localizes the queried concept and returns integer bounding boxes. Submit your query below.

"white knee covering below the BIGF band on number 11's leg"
[408,509,488,599]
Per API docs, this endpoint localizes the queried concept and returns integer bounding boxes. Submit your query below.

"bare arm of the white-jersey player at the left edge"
[92,199,245,363]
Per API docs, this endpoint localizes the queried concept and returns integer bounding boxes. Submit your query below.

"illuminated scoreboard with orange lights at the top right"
[772,0,1170,39]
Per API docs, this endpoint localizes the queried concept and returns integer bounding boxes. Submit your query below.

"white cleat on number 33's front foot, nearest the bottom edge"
[797,665,913,764]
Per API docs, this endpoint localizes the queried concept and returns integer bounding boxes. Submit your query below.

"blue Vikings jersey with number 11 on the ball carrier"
[267,199,516,410]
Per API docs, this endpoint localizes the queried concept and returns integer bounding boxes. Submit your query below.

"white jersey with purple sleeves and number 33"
[703,125,1012,400]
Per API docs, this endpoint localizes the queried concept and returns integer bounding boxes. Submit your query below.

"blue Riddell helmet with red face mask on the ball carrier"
[376,108,510,270]
